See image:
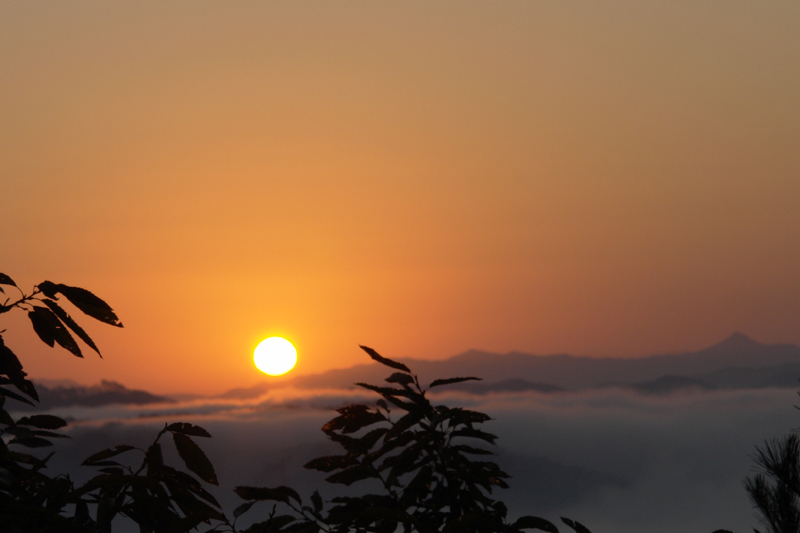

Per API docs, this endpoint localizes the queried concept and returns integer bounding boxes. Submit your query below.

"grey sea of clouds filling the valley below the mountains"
[14,389,800,533]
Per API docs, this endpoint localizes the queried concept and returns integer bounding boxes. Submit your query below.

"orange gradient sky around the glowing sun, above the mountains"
[0,0,800,392]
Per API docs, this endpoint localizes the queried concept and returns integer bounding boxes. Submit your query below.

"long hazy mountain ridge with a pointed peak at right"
[224,333,800,398]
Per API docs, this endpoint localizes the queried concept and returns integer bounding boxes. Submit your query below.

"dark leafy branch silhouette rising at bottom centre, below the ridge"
[236,346,589,533]
